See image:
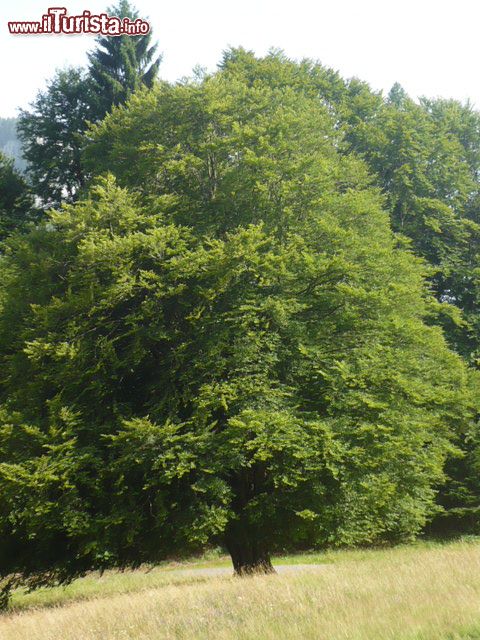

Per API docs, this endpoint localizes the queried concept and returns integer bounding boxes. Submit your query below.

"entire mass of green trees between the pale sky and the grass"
[0,0,480,602]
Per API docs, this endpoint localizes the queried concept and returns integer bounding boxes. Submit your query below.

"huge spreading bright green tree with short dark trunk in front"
[0,61,472,595]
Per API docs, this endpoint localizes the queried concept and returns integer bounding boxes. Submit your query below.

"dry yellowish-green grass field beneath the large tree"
[0,540,480,640]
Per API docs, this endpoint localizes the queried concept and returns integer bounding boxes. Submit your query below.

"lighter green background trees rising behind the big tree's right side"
[346,88,480,363]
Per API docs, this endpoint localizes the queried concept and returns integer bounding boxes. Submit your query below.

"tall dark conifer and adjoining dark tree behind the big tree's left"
[17,0,161,208]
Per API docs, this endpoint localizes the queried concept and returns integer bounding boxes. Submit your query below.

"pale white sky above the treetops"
[0,0,480,116]
